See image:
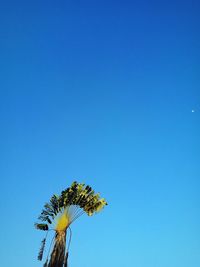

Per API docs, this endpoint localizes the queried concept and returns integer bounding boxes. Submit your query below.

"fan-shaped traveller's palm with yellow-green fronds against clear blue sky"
[35,182,107,267]
